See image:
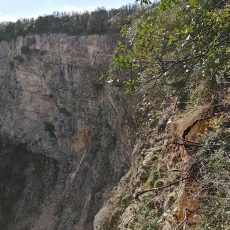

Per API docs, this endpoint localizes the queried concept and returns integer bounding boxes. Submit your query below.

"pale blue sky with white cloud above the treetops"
[0,0,135,22]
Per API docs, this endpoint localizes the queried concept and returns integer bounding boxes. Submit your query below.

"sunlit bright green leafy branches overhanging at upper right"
[109,0,230,93]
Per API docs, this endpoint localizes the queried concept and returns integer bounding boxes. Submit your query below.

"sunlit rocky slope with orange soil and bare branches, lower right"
[94,94,230,230]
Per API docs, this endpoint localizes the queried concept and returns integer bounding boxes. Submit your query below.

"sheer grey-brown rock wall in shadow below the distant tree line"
[0,34,132,230]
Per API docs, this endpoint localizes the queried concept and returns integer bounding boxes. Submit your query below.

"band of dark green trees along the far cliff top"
[0,5,137,41]
